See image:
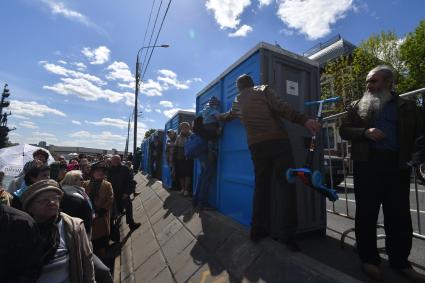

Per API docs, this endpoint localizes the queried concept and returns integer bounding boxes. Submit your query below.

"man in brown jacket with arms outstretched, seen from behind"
[217,75,320,251]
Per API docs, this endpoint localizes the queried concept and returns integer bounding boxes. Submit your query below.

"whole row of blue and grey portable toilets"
[141,42,326,233]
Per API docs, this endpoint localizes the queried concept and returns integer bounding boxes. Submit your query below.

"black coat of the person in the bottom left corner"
[0,204,42,283]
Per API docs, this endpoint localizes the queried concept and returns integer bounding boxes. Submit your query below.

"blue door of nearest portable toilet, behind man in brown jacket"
[218,52,261,226]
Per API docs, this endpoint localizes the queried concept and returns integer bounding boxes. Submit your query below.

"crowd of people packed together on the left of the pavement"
[0,149,140,283]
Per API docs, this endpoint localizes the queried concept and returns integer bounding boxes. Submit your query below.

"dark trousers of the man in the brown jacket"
[250,139,298,241]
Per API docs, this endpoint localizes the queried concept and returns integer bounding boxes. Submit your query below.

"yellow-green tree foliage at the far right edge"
[400,20,425,91]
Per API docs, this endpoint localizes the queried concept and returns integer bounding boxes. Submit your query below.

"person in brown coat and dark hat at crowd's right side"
[83,162,114,259]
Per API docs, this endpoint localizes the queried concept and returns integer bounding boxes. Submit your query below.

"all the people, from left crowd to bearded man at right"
[0,66,425,282]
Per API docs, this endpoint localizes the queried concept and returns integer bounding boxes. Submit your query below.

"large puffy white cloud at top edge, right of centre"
[277,0,353,40]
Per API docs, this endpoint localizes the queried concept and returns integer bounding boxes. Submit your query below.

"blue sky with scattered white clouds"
[0,0,425,150]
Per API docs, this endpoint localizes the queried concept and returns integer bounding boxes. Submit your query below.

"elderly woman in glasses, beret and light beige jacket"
[21,179,95,283]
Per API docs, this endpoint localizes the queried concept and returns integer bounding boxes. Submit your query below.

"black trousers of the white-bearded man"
[354,149,413,269]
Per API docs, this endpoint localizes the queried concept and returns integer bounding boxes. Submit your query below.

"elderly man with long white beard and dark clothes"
[340,66,425,282]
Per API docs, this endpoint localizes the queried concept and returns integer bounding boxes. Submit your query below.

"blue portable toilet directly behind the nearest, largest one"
[162,110,195,188]
